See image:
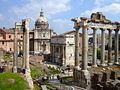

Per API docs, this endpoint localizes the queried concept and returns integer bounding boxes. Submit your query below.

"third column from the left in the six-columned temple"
[92,28,97,67]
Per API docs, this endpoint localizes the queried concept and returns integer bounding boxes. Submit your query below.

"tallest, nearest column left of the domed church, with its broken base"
[22,19,34,90]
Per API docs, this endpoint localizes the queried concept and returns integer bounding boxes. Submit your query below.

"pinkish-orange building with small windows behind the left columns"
[0,29,23,52]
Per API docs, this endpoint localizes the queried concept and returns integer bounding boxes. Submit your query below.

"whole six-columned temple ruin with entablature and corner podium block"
[72,12,120,88]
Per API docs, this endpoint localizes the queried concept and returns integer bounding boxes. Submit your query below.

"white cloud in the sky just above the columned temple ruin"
[81,3,120,16]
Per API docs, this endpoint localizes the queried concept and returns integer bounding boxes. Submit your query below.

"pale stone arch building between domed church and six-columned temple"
[51,30,82,66]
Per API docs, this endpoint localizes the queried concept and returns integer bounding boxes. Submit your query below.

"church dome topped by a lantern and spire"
[35,10,49,29]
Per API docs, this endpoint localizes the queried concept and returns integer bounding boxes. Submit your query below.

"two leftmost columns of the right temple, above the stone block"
[75,26,88,70]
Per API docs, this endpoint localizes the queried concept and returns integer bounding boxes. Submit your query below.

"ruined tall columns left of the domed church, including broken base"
[13,19,33,90]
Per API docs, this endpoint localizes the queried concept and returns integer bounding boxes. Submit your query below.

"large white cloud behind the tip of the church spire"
[12,0,71,19]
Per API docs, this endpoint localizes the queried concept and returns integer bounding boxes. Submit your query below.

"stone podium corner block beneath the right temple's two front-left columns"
[74,70,91,90]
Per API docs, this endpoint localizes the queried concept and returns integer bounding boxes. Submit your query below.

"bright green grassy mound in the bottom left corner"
[0,73,29,90]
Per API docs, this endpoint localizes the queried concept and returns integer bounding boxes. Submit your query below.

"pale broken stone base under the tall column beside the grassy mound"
[25,69,34,90]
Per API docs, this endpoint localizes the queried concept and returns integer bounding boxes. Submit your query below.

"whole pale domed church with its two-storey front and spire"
[32,10,56,54]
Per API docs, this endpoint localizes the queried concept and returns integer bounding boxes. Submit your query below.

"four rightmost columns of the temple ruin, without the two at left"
[92,28,119,67]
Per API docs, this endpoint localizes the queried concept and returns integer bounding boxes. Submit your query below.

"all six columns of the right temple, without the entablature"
[75,26,119,70]
